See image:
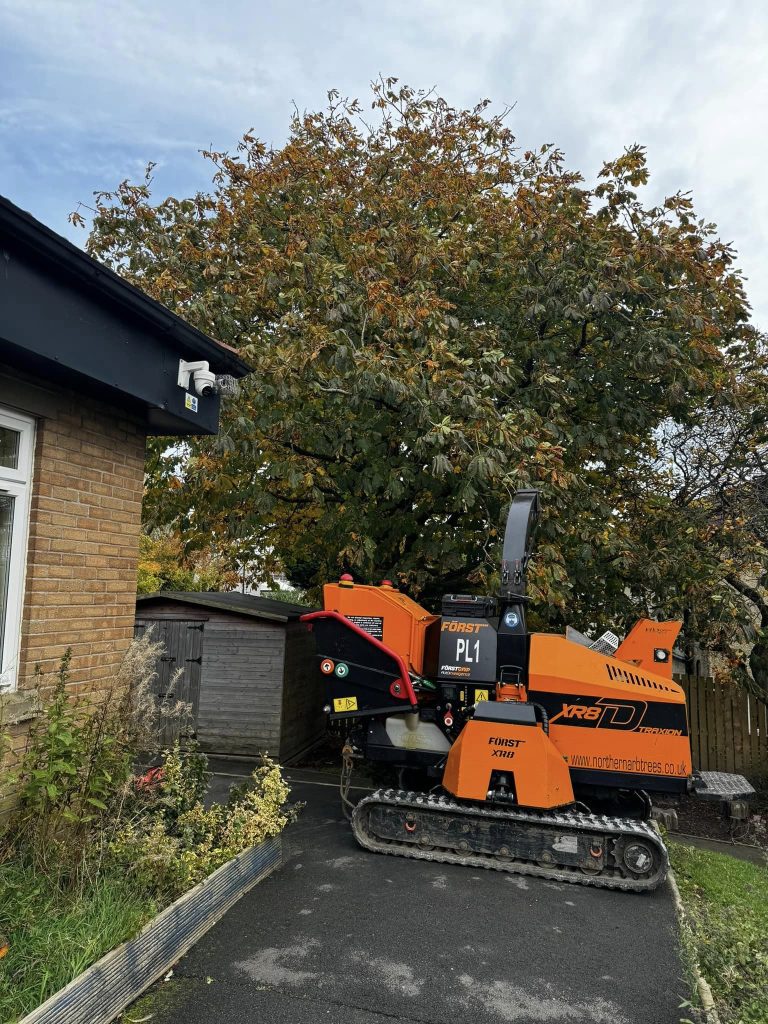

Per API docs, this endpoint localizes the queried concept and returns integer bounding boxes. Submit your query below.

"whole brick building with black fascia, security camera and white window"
[0,196,251,811]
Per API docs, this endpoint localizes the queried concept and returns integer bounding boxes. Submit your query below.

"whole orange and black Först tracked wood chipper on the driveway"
[303,490,754,892]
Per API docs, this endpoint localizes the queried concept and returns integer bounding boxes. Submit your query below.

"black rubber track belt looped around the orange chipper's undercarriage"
[352,790,669,892]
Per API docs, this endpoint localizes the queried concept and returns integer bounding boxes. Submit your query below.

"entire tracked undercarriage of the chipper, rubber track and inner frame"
[352,790,669,892]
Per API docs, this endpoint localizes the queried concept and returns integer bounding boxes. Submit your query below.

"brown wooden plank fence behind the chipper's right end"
[676,676,768,777]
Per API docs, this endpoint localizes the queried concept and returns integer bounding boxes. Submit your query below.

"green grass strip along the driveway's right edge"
[670,843,768,1024]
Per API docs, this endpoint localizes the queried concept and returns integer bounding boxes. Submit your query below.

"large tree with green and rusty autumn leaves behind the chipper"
[76,80,758,671]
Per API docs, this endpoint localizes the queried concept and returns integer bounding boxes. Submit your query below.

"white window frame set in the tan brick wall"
[0,407,35,693]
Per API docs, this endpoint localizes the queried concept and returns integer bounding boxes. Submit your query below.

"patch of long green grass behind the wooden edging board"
[0,863,158,1024]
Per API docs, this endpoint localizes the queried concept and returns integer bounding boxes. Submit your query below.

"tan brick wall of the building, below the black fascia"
[0,371,145,813]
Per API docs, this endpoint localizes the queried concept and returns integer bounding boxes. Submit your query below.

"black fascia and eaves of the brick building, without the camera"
[0,197,250,435]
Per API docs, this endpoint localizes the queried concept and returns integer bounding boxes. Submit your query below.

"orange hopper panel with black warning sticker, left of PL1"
[323,582,439,675]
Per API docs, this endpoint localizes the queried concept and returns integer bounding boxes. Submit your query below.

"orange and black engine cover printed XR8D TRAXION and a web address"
[528,634,691,788]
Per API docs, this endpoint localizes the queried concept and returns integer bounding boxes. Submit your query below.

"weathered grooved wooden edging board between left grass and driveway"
[19,836,283,1024]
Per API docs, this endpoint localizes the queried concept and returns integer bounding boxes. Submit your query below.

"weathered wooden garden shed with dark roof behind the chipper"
[136,592,326,764]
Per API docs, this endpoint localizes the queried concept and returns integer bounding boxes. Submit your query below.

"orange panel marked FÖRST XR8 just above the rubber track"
[442,706,573,809]
